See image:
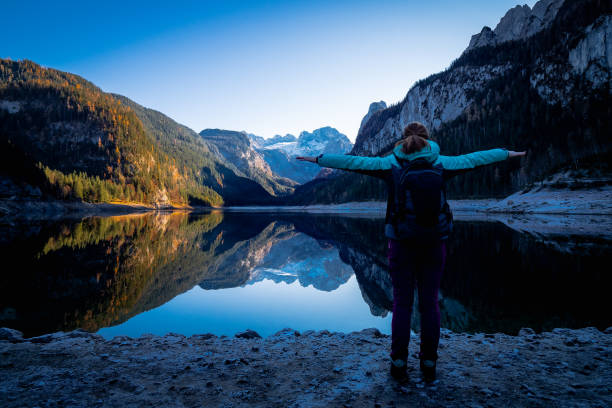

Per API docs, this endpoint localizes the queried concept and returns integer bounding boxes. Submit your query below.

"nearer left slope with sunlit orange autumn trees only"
[0,60,222,205]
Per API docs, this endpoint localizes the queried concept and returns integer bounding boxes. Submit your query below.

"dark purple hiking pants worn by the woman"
[388,239,446,361]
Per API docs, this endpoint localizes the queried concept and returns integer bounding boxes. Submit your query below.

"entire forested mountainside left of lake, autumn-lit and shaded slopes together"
[0,60,270,206]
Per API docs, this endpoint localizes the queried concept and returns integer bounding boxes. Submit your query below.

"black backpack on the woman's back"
[391,156,452,240]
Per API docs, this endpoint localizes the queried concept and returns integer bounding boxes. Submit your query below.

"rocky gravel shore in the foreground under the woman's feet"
[0,327,612,408]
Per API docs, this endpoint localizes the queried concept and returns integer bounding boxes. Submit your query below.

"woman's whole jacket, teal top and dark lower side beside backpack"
[317,140,508,239]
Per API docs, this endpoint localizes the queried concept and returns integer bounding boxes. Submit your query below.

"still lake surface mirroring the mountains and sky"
[0,211,612,336]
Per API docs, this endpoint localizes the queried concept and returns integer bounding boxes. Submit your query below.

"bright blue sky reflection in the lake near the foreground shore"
[98,275,391,338]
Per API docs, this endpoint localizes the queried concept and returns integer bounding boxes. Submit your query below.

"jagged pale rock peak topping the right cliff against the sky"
[465,0,564,52]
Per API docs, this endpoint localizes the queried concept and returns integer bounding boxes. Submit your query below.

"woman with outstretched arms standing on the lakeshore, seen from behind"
[297,122,525,382]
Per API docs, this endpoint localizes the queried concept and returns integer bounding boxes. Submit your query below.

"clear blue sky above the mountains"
[0,0,535,140]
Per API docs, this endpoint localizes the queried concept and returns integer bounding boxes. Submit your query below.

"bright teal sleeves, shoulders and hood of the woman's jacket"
[317,140,508,172]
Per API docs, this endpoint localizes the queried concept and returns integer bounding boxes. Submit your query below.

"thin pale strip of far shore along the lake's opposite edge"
[0,186,612,223]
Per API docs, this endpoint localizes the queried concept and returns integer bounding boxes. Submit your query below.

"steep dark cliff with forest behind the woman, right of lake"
[292,0,612,203]
